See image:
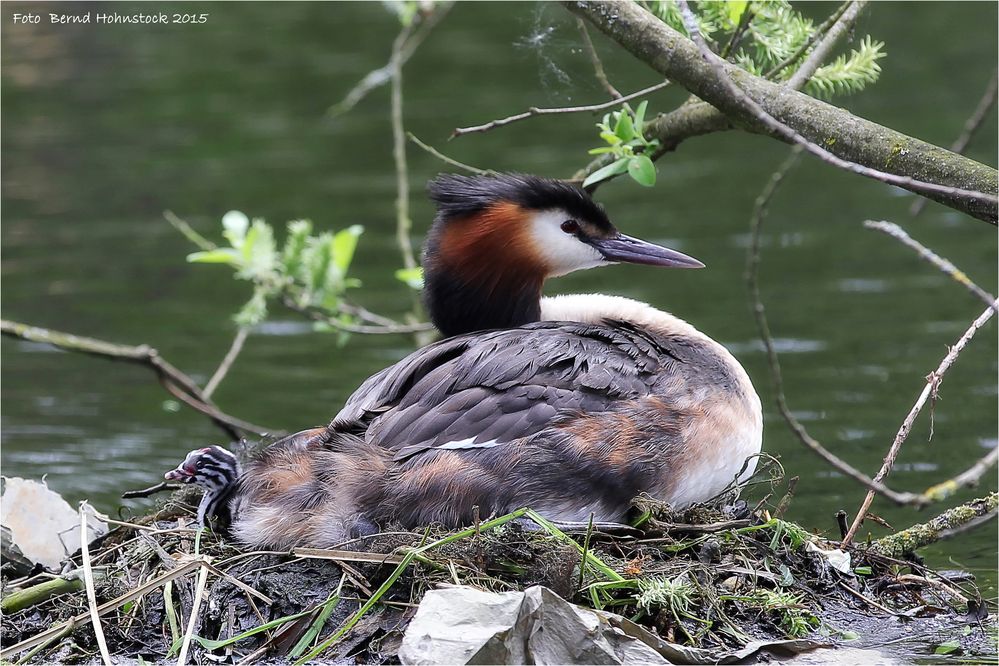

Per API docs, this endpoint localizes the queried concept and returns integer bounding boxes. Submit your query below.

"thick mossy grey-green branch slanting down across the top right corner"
[565,0,999,223]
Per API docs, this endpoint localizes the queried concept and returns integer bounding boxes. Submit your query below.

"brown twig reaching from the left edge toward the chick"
[0,319,277,439]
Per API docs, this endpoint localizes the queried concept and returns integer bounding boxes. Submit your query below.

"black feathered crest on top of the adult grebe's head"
[428,173,613,230]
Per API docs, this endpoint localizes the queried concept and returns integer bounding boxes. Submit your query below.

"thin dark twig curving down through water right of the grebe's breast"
[746,146,925,505]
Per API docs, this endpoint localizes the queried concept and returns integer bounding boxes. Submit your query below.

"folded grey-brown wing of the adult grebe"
[336,322,676,460]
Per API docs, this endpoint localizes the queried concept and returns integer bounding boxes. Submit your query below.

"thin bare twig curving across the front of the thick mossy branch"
[677,0,999,215]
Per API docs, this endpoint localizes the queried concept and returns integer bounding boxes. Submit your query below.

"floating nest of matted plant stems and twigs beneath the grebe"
[2,460,996,664]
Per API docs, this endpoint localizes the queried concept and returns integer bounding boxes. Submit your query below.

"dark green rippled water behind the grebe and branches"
[2,2,997,597]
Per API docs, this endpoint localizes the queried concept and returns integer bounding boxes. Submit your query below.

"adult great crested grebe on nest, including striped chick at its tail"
[166,175,763,548]
